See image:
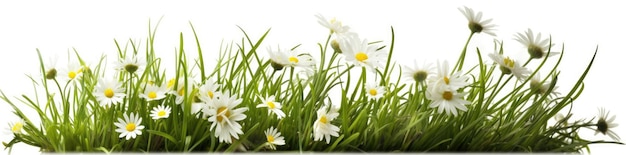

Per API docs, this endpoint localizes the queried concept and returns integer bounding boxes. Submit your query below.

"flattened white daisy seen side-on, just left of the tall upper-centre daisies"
[268,47,315,70]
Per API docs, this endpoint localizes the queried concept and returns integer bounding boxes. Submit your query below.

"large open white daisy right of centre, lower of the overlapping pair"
[426,85,470,116]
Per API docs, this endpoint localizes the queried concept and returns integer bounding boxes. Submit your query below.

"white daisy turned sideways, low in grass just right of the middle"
[313,106,339,144]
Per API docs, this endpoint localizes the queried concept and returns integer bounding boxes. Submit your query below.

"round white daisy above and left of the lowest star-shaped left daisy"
[93,78,126,106]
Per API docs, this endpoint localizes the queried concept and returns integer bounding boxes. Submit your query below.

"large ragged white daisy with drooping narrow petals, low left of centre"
[208,94,248,143]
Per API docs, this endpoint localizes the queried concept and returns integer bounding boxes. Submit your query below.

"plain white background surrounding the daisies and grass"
[0,0,626,154]
